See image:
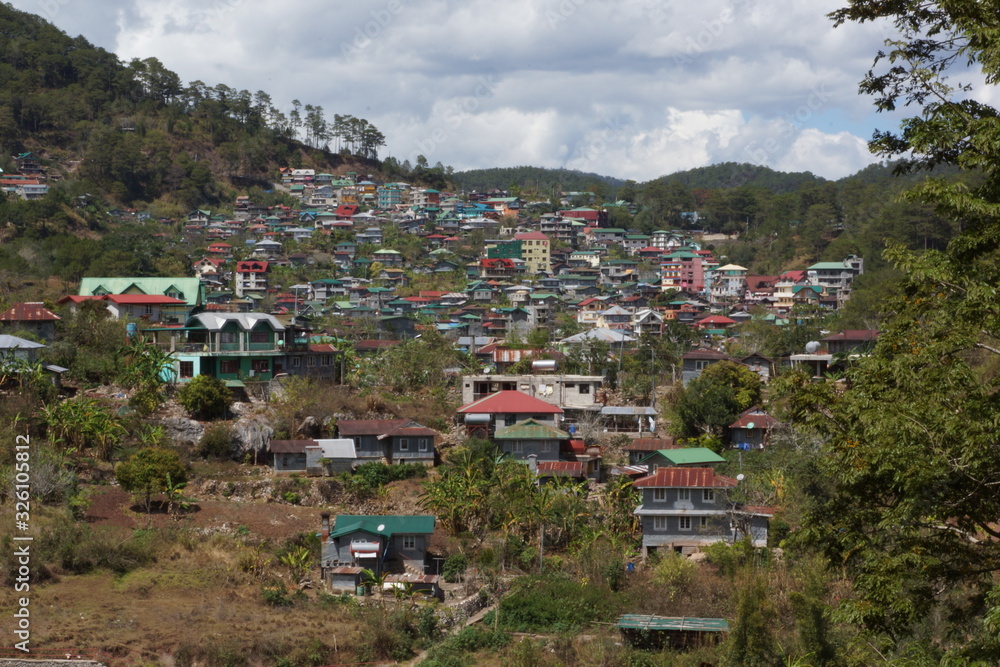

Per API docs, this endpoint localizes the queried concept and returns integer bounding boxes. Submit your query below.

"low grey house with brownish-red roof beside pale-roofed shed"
[337,419,438,466]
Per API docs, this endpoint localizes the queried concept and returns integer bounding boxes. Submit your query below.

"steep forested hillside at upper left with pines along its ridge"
[0,4,385,207]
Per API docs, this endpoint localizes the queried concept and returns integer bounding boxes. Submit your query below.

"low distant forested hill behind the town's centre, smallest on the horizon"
[452,167,625,195]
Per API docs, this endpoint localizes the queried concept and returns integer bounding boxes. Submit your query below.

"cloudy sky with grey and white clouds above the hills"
[12,0,916,181]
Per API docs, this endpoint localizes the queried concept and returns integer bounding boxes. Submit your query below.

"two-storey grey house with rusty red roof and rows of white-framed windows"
[633,468,772,557]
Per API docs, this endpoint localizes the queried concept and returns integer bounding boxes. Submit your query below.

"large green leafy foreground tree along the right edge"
[792,0,1000,664]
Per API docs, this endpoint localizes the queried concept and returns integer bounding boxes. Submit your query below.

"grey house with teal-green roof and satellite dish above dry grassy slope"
[320,512,434,583]
